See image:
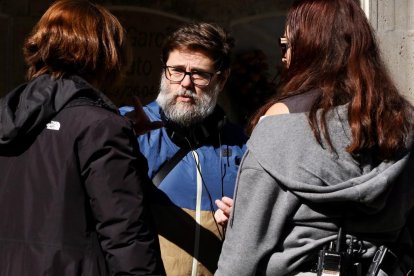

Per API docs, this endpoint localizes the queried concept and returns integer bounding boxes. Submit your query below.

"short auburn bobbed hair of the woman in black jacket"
[23,0,130,89]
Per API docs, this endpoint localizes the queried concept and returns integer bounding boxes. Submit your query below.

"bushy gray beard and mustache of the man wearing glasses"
[156,75,220,127]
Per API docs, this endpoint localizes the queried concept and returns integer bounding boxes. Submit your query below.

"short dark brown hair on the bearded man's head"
[162,22,234,75]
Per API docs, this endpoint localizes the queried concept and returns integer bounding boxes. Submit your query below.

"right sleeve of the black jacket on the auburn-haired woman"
[79,114,162,275]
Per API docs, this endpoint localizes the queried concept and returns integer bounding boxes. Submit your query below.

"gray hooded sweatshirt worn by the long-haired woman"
[215,105,414,276]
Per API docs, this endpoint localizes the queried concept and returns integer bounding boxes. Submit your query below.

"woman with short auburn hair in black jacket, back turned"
[0,0,163,276]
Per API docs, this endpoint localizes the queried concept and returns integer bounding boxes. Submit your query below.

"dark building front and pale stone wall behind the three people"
[0,0,414,125]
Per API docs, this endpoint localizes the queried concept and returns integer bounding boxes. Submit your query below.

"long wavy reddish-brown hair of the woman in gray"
[247,0,412,160]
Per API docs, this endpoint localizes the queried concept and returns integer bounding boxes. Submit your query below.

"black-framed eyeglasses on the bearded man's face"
[164,66,221,86]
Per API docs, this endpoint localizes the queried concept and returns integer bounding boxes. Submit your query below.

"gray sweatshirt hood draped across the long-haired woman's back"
[247,105,414,217]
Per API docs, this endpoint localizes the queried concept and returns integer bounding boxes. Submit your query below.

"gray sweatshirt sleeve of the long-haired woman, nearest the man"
[214,151,297,276]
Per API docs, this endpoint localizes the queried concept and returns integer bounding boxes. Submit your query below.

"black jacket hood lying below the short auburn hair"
[0,74,116,147]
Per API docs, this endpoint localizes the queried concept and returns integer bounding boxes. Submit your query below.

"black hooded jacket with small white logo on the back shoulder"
[0,75,162,276]
